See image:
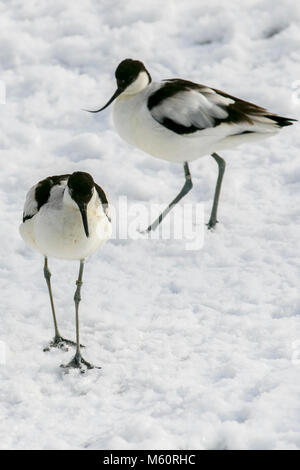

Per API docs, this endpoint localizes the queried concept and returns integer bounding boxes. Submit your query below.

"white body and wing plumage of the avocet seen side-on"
[113,81,279,163]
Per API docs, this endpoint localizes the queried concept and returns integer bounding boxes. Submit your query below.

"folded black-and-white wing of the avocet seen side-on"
[147,79,295,134]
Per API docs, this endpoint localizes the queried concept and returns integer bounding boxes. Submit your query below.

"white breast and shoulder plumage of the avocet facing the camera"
[20,175,111,260]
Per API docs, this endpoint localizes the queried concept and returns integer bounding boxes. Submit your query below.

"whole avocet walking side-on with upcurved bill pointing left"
[86,59,295,231]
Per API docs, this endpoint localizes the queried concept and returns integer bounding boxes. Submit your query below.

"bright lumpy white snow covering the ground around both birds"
[0,0,300,449]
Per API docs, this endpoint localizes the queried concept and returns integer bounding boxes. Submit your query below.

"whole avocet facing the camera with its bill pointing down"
[20,171,111,370]
